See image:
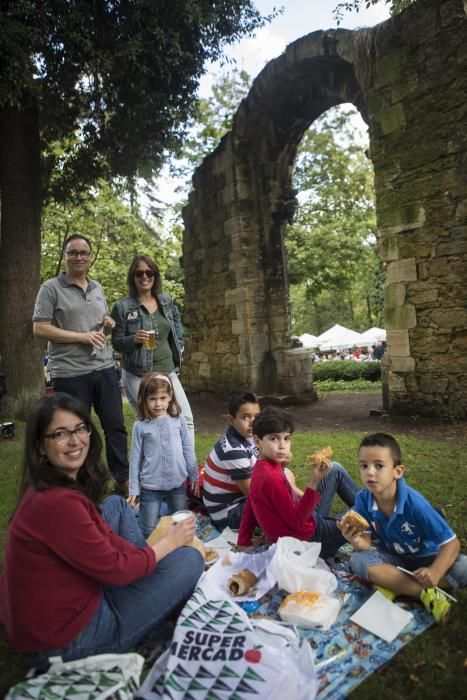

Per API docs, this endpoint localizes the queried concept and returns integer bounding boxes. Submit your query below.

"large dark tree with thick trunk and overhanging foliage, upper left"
[0,0,268,412]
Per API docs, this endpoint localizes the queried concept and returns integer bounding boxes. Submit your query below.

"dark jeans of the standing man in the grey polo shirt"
[53,367,129,481]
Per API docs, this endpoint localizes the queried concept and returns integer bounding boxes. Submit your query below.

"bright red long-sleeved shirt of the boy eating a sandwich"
[238,459,320,547]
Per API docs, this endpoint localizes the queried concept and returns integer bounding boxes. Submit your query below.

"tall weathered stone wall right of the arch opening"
[367,0,467,417]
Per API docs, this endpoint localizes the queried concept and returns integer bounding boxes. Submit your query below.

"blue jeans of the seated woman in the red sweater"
[40,496,204,661]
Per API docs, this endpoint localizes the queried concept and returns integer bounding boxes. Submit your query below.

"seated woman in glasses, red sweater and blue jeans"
[0,393,204,665]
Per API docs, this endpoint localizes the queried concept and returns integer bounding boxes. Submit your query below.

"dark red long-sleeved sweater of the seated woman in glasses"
[0,488,156,652]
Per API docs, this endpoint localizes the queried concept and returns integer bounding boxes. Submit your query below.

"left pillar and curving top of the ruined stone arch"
[184,31,367,399]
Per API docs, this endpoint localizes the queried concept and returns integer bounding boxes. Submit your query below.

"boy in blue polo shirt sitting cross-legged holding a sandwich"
[341,433,467,623]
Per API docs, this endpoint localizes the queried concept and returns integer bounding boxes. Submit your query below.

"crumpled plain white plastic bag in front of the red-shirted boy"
[270,537,337,595]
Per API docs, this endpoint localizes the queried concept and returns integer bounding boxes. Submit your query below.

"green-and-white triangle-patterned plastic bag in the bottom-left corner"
[5,654,144,700]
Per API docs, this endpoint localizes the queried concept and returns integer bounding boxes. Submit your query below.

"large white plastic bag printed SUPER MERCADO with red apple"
[137,576,318,700]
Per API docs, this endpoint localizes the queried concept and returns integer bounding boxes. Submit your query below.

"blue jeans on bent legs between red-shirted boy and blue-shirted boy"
[311,462,358,559]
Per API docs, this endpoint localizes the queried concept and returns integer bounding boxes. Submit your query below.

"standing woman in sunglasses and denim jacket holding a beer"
[111,255,194,444]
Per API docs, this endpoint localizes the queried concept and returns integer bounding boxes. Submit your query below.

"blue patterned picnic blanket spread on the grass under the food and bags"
[196,513,433,700]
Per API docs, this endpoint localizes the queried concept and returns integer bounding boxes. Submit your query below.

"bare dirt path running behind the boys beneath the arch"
[190,394,467,444]
